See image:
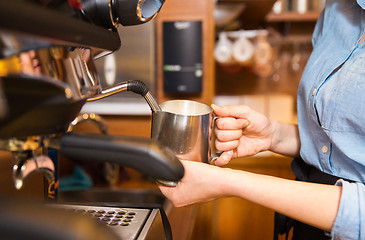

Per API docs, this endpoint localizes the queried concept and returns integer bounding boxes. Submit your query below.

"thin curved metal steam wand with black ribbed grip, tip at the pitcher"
[87,80,161,113]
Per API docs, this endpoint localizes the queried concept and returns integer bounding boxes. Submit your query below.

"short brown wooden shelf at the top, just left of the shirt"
[266,11,321,22]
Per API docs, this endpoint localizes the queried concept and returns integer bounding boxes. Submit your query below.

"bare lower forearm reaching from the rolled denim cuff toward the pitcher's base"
[220,169,342,231]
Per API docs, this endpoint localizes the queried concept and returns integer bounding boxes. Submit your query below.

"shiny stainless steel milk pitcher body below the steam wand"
[152,100,213,163]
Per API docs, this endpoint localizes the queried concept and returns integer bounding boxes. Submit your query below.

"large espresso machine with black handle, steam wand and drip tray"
[0,0,184,239]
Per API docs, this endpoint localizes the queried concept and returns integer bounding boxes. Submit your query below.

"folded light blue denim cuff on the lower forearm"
[331,180,365,239]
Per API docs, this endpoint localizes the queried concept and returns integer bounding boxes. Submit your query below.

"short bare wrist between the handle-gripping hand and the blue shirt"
[269,120,300,157]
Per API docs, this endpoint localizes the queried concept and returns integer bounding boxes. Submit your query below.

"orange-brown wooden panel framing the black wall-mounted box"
[156,0,215,104]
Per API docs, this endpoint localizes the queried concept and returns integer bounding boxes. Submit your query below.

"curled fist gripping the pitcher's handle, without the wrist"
[212,105,274,166]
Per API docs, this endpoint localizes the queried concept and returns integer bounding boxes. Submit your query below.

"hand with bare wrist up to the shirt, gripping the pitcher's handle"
[212,105,300,166]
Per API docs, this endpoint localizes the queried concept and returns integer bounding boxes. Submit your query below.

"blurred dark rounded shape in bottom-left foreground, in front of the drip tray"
[0,200,120,240]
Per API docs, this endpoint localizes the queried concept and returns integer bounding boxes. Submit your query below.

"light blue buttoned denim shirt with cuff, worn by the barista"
[298,0,365,239]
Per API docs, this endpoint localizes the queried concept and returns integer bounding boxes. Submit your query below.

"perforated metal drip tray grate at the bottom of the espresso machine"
[53,204,159,240]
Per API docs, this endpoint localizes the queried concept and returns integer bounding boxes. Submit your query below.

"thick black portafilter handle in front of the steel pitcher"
[59,132,184,183]
